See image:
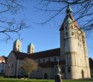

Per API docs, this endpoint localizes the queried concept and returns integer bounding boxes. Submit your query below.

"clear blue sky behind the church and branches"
[0,0,93,58]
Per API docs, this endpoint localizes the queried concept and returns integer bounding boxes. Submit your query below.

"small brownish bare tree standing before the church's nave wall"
[21,58,38,78]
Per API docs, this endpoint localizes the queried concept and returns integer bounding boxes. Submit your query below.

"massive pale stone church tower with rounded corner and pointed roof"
[60,5,90,79]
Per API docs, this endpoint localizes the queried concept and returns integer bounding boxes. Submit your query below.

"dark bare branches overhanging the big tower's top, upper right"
[31,0,93,31]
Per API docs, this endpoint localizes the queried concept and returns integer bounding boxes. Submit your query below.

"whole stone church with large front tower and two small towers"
[5,6,91,79]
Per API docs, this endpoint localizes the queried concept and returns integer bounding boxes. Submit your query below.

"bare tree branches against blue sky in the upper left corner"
[0,0,27,41]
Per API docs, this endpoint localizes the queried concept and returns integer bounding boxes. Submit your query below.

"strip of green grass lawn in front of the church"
[0,78,93,82]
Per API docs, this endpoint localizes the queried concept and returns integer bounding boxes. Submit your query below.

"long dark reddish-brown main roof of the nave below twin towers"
[12,48,60,60]
